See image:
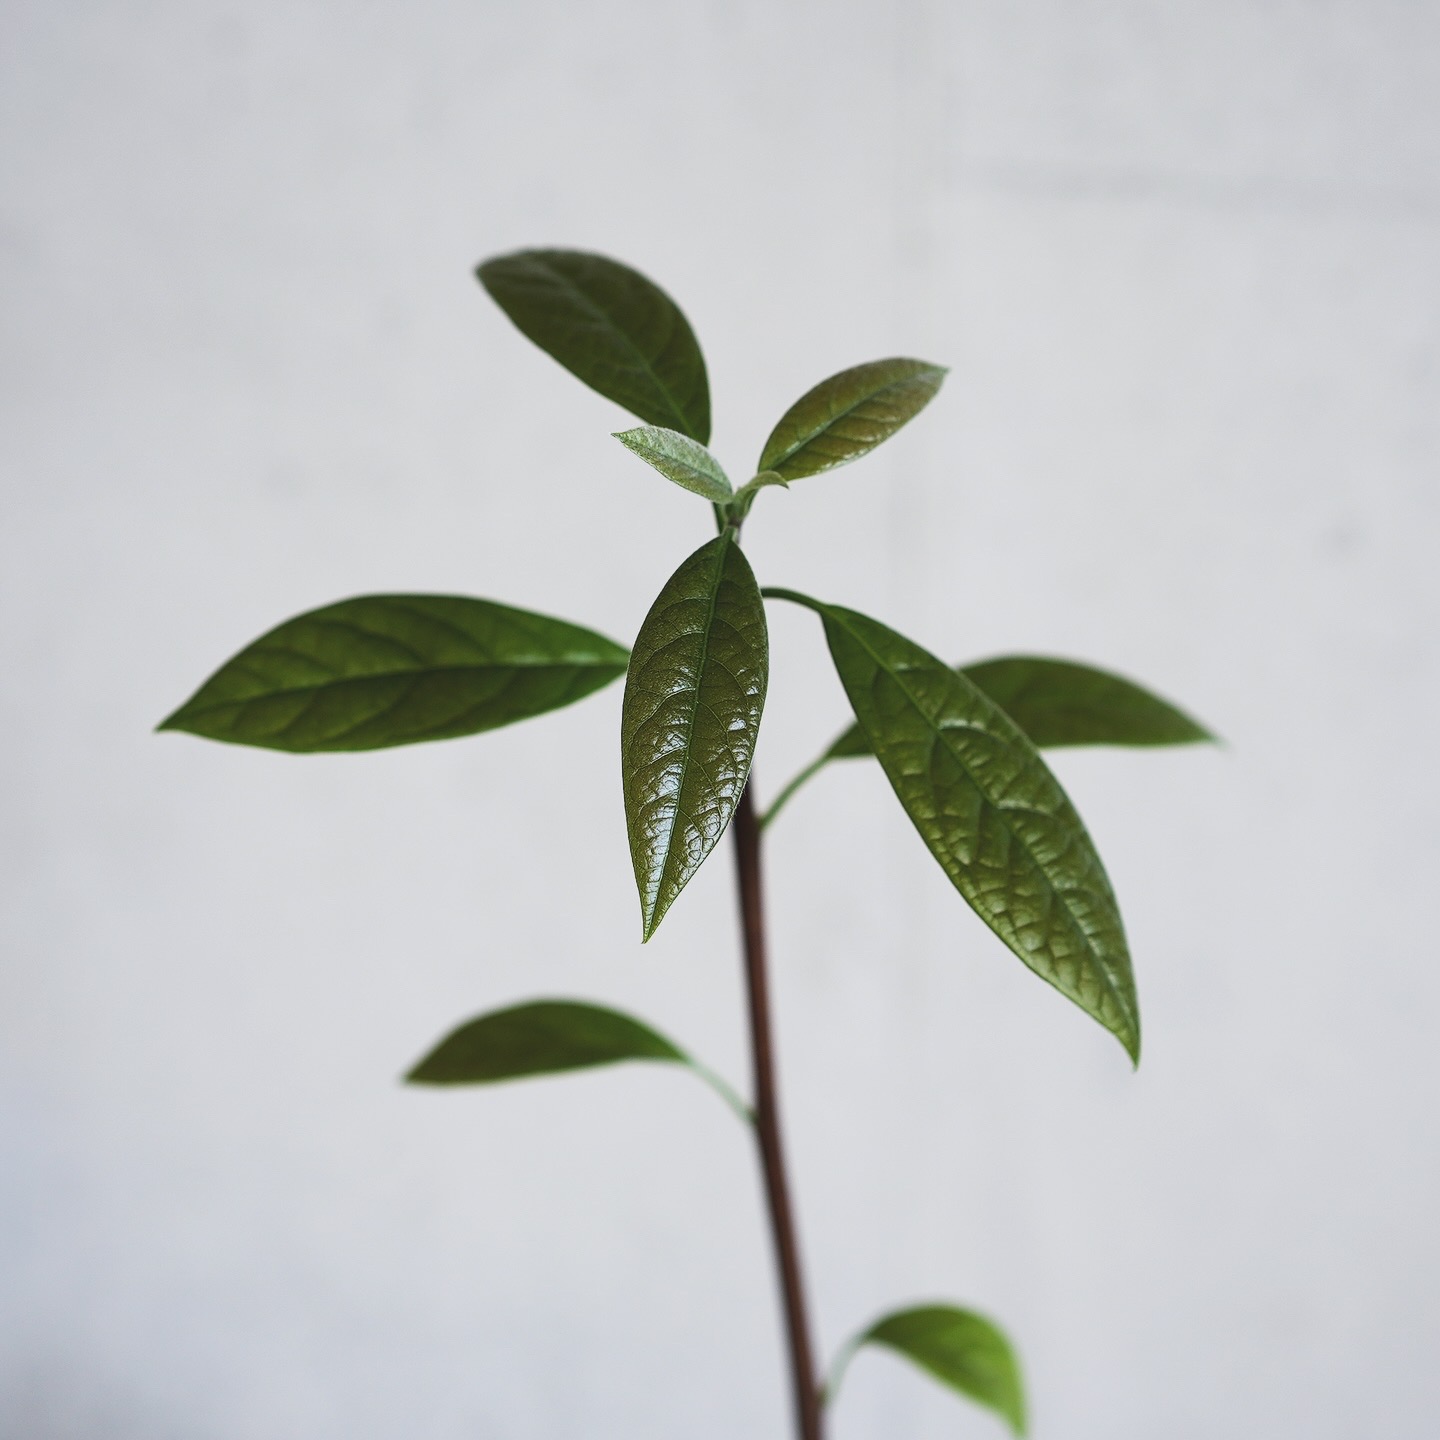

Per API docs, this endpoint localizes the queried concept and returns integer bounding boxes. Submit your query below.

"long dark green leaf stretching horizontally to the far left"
[158,595,628,752]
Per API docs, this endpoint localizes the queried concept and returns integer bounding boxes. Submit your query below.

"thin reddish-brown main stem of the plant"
[734,783,821,1440]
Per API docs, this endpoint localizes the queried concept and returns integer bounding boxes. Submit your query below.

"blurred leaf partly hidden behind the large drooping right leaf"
[825,655,1215,760]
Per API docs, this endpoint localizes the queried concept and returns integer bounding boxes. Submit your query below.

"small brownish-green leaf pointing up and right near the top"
[756,360,945,480]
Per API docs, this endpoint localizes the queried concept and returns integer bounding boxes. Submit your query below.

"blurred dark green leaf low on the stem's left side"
[405,999,690,1084]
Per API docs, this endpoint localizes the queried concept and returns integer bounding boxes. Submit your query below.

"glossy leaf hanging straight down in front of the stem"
[621,530,769,940]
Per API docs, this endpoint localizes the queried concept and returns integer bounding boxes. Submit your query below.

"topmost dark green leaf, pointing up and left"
[475,251,710,445]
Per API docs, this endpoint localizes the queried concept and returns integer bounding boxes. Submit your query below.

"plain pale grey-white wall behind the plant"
[0,0,1440,1440]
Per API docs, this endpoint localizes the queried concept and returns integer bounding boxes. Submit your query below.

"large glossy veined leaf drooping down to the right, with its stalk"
[766,590,1140,1061]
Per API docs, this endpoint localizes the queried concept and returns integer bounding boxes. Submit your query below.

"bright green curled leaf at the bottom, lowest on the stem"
[827,1305,1025,1436]
